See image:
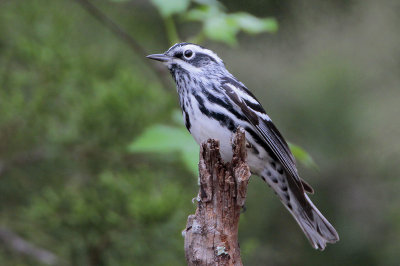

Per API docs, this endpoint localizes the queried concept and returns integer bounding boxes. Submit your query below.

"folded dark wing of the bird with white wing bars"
[222,79,304,190]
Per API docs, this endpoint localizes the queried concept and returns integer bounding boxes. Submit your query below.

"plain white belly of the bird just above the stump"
[190,117,233,162]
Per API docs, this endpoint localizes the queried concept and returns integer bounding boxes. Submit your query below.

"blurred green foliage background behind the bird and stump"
[0,0,400,265]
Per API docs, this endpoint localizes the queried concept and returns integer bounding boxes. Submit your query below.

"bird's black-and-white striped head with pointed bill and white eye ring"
[147,43,225,75]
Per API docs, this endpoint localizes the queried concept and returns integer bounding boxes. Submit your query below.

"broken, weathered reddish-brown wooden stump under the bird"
[184,128,250,266]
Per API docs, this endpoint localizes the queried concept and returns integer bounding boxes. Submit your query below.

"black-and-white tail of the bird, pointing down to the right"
[263,171,339,250]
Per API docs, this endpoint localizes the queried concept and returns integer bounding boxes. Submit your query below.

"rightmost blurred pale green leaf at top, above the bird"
[231,12,278,34]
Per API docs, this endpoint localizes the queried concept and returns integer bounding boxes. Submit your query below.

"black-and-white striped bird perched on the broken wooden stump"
[147,42,339,250]
